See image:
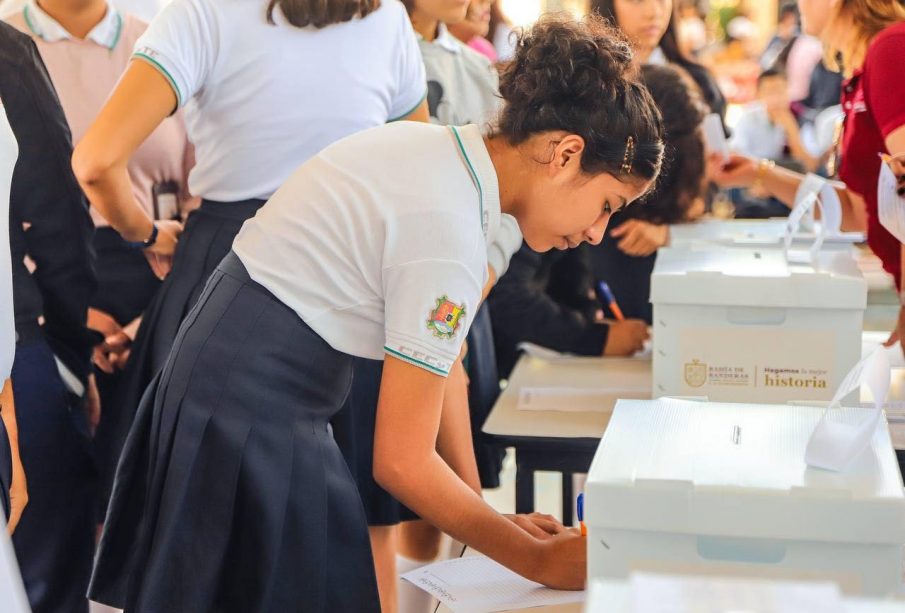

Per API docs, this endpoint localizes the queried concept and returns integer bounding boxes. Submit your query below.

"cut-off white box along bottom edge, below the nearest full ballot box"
[584,575,905,613]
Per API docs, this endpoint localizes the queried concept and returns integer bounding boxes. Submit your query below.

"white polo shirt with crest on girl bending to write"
[233,122,500,376]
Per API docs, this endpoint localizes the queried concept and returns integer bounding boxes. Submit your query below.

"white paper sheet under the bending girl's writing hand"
[402,556,585,613]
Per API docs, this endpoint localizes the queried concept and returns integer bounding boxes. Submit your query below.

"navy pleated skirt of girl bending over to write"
[89,254,380,613]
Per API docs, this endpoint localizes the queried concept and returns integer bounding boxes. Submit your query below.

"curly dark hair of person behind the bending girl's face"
[617,65,709,224]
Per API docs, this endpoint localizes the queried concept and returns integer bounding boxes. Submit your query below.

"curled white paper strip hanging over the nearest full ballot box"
[805,347,895,471]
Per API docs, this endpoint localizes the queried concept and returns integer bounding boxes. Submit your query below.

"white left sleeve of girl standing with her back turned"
[132,0,217,107]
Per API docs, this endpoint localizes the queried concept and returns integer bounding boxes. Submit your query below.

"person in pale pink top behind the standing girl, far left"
[7,0,198,532]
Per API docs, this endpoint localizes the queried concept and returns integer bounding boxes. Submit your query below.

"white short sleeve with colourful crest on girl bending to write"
[383,212,487,377]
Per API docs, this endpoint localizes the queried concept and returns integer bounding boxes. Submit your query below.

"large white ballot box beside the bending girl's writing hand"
[585,398,905,597]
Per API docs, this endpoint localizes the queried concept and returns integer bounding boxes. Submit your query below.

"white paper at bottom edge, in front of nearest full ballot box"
[630,573,844,613]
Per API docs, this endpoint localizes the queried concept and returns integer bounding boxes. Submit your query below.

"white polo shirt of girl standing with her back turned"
[134,0,426,202]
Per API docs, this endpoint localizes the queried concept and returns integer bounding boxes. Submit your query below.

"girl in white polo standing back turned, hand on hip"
[73,0,427,500]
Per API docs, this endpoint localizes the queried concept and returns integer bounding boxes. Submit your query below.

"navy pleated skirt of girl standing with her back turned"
[102,200,264,512]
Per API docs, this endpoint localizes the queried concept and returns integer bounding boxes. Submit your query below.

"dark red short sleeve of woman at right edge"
[864,29,905,138]
